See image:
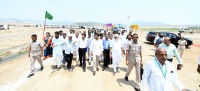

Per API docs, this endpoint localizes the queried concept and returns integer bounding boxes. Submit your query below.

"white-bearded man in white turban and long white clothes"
[110,34,123,75]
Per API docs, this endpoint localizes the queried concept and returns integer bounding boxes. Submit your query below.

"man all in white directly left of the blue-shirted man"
[90,34,103,75]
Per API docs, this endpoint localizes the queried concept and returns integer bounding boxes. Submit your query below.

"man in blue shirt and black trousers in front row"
[102,35,110,71]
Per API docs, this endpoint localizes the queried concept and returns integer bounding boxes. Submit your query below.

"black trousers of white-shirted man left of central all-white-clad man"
[78,48,86,67]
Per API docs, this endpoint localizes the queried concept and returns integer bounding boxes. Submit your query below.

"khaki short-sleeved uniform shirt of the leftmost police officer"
[30,41,44,56]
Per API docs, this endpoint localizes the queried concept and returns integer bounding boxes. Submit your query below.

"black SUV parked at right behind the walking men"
[146,32,193,48]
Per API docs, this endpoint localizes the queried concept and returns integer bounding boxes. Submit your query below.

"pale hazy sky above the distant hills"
[0,0,200,25]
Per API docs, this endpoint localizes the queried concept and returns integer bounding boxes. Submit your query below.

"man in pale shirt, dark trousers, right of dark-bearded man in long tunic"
[65,34,74,69]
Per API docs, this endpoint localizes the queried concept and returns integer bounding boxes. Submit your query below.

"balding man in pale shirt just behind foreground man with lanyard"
[158,37,183,69]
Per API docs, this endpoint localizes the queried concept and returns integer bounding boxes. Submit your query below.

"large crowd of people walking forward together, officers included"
[28,31,200,91]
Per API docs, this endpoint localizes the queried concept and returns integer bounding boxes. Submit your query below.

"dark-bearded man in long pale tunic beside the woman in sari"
[52,31,65,70]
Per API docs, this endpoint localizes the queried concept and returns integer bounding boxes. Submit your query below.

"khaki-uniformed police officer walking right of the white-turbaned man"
[125,34,142,91]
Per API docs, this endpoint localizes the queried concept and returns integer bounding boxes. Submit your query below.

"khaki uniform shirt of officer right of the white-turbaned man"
[126,41,142,62]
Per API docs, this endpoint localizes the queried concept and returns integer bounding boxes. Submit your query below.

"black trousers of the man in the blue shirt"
[103,49,110,68]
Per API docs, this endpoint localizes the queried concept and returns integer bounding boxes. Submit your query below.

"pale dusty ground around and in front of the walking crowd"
[0,28,200,91]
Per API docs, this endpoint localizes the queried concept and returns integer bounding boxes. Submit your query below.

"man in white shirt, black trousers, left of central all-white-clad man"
[78,33,88,72]
